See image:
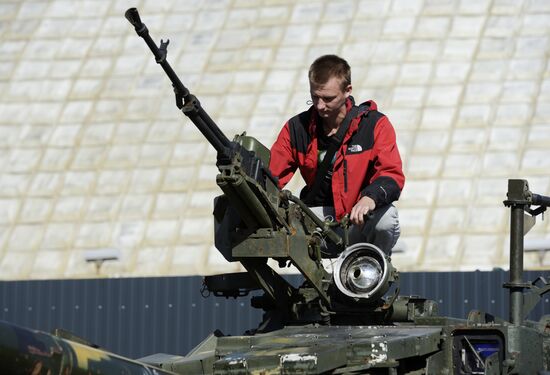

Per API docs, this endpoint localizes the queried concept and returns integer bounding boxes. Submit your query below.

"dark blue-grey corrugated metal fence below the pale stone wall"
[0,270,550,358]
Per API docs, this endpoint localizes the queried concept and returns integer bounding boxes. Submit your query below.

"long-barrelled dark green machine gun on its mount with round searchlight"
[125,8,420,324]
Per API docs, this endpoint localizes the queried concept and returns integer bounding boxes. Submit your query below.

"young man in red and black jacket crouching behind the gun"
[269,55,405,256]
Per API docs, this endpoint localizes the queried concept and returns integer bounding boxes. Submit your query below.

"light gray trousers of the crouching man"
[310,204,401,258]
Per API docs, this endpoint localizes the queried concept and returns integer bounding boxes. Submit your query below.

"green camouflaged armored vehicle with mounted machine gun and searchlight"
[0,8,550,374]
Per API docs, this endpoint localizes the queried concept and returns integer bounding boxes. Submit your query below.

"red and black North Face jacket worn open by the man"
[269,97,405,220]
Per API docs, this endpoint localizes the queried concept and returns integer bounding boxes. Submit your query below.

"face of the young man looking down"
[309,77,351,120]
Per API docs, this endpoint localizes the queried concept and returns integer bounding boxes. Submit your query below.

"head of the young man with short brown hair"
[308,55,352,120]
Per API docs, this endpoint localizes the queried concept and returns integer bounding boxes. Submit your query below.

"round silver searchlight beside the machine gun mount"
[333,243,394,300]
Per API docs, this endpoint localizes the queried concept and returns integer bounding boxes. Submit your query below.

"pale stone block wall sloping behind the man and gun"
[0,0,550,279]
